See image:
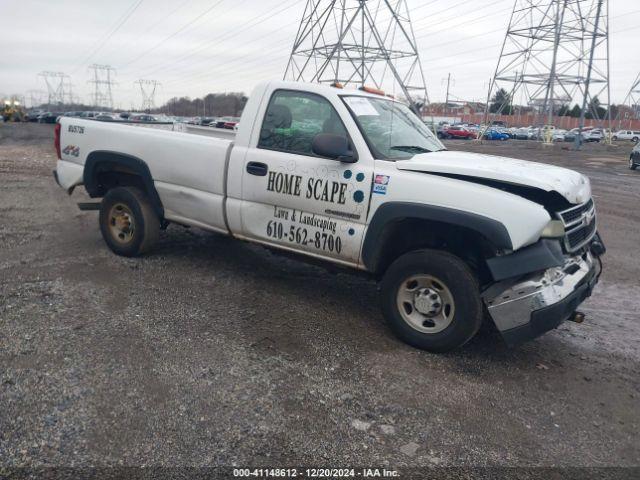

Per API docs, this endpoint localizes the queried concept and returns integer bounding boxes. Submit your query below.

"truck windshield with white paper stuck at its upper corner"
[342,96,445,160]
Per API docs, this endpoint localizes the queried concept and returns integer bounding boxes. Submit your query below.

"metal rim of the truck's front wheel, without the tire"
[396,275,455,334]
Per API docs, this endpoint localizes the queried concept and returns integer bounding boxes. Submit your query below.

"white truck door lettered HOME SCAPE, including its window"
[241,89,373,264]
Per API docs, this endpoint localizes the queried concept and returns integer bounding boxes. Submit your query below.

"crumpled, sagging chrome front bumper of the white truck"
[483,236,604,346]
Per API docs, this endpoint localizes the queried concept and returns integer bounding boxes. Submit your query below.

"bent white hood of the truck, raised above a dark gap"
[396,150,591,204]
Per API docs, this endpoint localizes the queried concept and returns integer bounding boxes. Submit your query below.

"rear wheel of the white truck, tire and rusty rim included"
[99,187,160,257]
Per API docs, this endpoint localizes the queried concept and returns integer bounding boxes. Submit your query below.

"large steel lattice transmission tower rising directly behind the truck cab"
[284,0,428,113]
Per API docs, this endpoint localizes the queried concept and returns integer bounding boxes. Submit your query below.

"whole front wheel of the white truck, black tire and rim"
[380,249,483,353]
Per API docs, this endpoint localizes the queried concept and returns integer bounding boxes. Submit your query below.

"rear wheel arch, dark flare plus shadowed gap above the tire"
[83,151,164,219]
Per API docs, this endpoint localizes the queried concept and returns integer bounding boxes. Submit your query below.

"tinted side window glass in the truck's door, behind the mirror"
[258,90,347,157]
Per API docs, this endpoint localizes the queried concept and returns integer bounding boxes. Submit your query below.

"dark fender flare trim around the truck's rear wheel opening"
[83,150,164,218]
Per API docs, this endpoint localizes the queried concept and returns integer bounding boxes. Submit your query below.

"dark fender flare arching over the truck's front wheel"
[362,202,513,272]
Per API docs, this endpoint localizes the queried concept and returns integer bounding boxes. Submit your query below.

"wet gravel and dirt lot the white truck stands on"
[0,124,640,467]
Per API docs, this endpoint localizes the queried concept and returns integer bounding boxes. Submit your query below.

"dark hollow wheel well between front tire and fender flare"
[374,218,495,284]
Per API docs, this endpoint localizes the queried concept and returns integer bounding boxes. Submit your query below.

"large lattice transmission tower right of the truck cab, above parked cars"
[485,0,610,142]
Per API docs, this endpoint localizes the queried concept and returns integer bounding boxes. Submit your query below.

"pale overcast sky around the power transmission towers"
[0,0,640,109]
